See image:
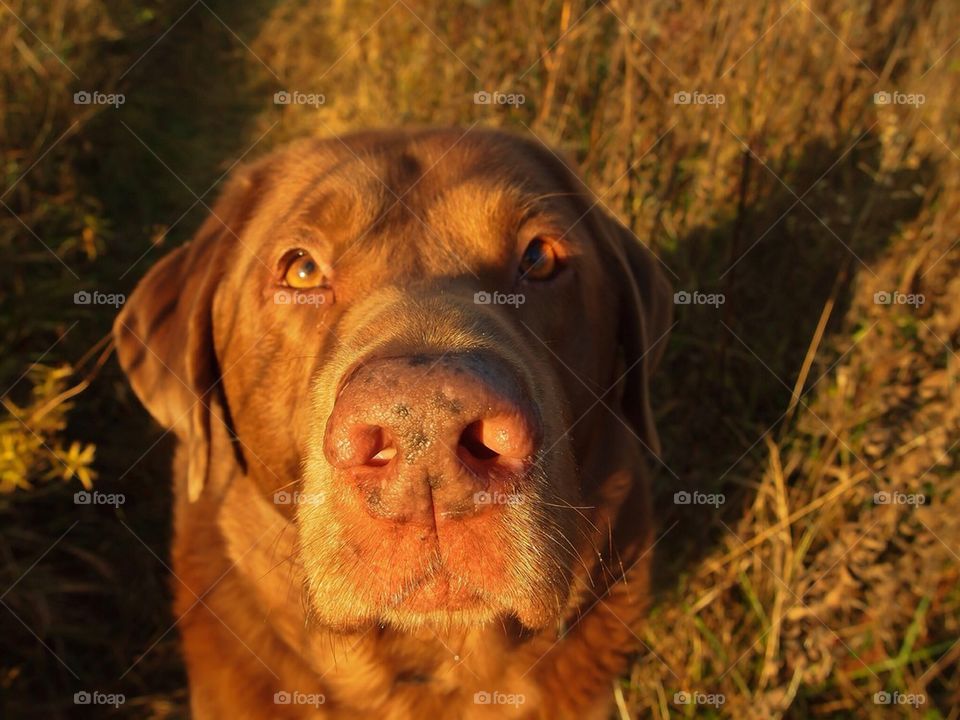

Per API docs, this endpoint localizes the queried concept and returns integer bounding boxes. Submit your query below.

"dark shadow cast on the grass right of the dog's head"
[654,135,934,602]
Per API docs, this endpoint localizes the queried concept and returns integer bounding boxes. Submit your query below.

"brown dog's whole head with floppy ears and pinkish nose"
[116,130,670,628]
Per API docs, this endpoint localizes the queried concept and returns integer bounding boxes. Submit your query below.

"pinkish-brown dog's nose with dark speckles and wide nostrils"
[324,354,542,524]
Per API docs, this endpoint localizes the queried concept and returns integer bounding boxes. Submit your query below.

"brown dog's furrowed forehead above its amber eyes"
[266,130,582,242]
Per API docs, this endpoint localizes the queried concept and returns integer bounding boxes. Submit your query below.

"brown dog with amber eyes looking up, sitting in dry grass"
[115,130,670,720]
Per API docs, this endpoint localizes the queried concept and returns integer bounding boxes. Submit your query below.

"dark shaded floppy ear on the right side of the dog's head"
[598,211,673,455]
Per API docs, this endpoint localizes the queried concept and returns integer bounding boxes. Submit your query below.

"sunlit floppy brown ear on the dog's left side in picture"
[113,161,265,501]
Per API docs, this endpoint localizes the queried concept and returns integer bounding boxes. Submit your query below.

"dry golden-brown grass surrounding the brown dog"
[0,0,960,718]
